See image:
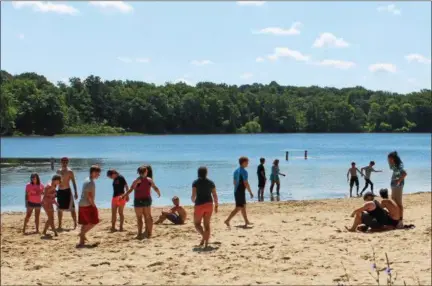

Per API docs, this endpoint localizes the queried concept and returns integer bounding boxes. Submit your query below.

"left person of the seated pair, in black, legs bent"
[345,192,391,232]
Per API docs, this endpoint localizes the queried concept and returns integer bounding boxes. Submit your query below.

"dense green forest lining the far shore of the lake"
[0,71,432,136]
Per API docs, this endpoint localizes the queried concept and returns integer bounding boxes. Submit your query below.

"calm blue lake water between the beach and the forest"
[1,134,431,211]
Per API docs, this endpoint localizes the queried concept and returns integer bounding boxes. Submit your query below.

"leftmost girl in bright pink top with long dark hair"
[23,173,44,234]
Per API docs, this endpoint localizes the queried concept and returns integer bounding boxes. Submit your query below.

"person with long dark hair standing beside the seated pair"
[387,151,407,228]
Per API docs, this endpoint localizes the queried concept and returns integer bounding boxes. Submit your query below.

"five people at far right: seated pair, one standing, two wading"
[347,151,413,231]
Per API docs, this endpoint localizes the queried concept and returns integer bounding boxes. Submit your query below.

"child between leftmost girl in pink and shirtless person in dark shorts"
[42,175,61,236]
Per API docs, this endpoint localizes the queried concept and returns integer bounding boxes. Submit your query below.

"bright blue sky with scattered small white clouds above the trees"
[1,1,431,93]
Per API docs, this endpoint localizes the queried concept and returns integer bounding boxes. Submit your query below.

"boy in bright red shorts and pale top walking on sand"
[77,165,101,247]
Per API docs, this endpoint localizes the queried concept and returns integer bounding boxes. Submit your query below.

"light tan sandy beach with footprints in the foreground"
[1,193,431,285]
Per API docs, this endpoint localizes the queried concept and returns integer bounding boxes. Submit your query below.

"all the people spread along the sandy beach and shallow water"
[23,152,407,247]
